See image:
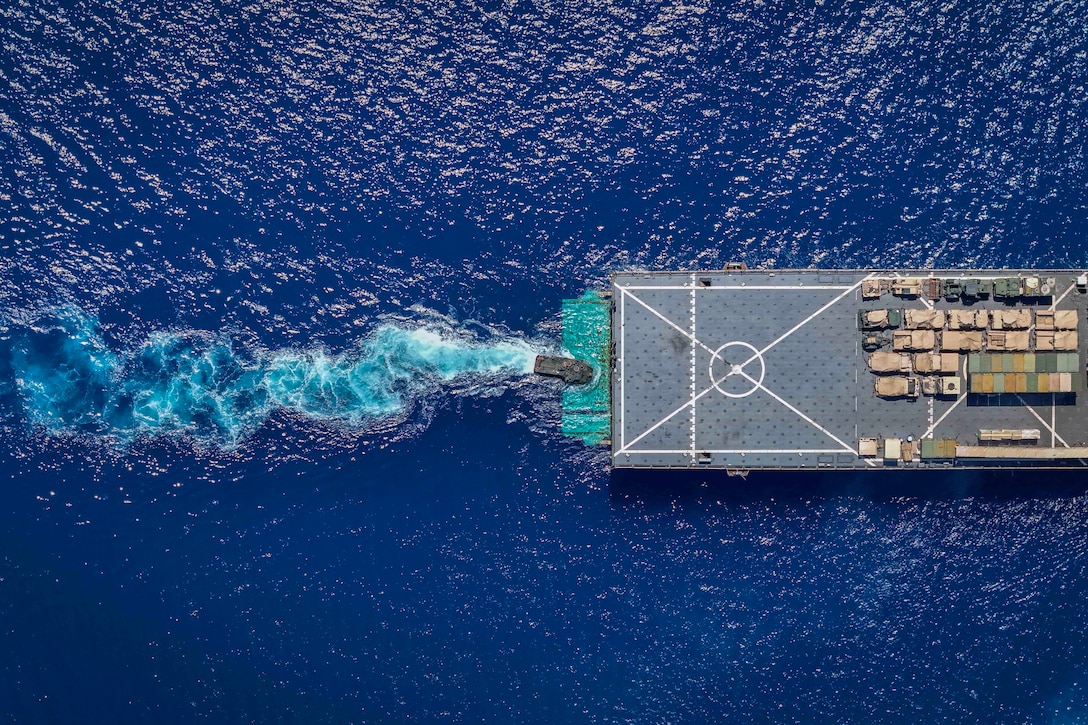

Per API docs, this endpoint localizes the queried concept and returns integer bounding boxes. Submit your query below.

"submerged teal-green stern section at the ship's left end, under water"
[562,290,611,445]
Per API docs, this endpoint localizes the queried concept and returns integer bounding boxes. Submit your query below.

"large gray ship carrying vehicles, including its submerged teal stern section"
[548,263,1088,468]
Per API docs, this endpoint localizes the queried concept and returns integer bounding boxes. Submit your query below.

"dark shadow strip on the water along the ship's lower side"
[609,468,1088,505]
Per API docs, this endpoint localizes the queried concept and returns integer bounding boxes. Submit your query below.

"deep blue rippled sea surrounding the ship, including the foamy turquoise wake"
[0,0,1088,725]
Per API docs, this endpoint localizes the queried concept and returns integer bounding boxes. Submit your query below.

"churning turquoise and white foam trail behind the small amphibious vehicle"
[3,309,536,445]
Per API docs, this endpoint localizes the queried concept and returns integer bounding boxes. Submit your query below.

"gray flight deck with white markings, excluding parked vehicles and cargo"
[611,270,1088,471]
